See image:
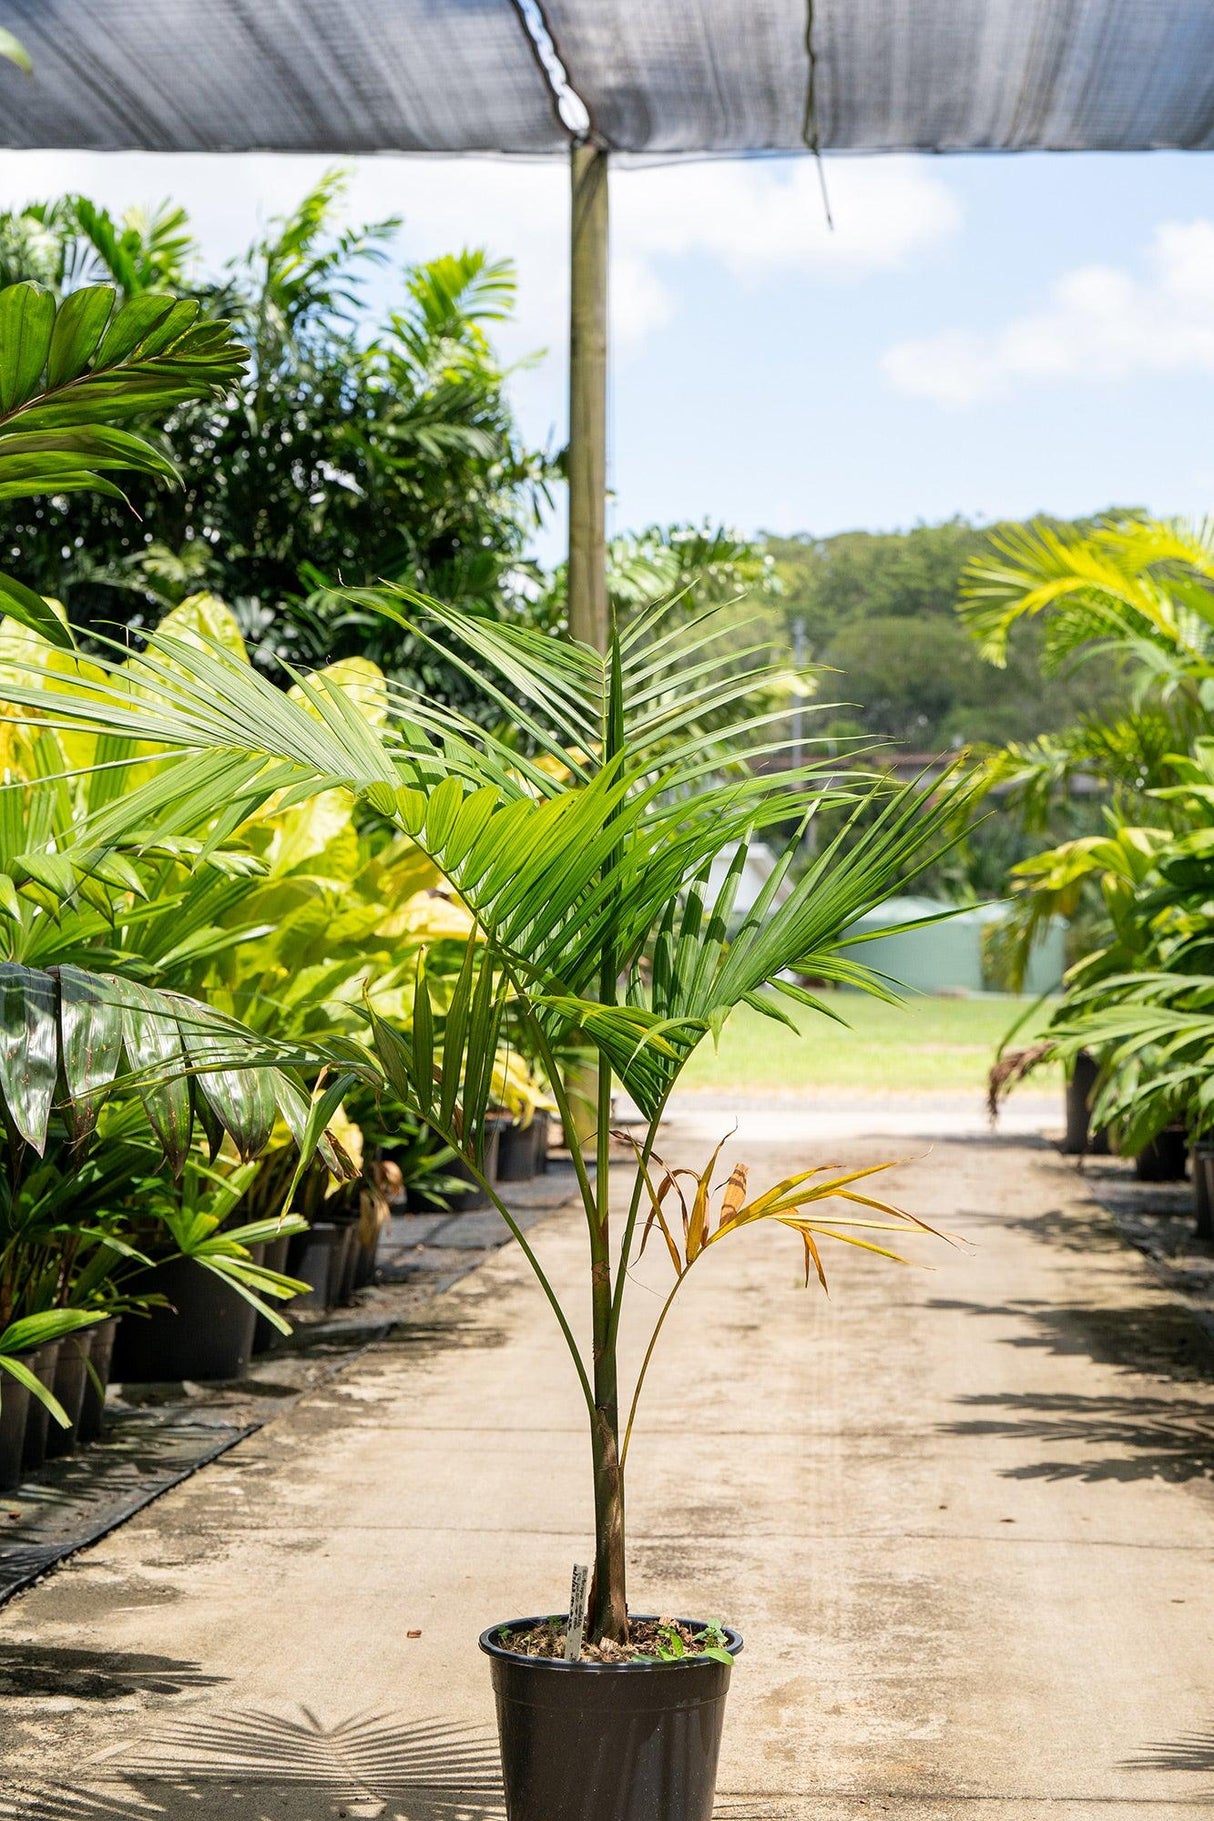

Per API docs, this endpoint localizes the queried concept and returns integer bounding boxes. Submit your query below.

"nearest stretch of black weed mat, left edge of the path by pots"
[0,1413,258,1606]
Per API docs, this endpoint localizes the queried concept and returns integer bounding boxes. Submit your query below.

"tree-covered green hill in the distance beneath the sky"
[764,519,1119,752]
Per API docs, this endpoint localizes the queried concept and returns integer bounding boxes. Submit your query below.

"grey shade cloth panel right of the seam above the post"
[544,0,1214,151]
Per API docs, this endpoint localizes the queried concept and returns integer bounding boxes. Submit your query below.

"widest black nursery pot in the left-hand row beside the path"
[113,1246,262,1384]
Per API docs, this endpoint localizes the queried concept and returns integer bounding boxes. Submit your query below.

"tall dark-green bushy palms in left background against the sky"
[0,173,551,699]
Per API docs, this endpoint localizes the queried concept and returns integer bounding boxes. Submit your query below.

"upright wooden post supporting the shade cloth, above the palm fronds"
[570,146,608,652]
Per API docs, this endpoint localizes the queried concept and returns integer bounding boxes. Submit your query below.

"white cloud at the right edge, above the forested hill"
[883,220,1214,406]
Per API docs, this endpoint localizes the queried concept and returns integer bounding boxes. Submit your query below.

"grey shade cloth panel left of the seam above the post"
[0,0,568,153]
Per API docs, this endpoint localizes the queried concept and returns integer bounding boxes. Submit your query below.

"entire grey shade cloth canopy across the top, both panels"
[0,0,1214,155]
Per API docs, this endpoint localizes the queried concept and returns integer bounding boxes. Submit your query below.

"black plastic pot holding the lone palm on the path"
[481,1619,743,1821]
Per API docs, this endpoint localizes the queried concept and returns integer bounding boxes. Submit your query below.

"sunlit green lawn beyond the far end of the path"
[683,992,1054,1094]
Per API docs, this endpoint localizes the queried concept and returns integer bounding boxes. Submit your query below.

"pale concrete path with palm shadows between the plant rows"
[0,1104,1214,1821]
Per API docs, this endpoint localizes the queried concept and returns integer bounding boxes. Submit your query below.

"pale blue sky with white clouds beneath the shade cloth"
[0,151,1214,554]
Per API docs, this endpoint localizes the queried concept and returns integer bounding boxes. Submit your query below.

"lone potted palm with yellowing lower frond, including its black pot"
[9,588,957,1821]
